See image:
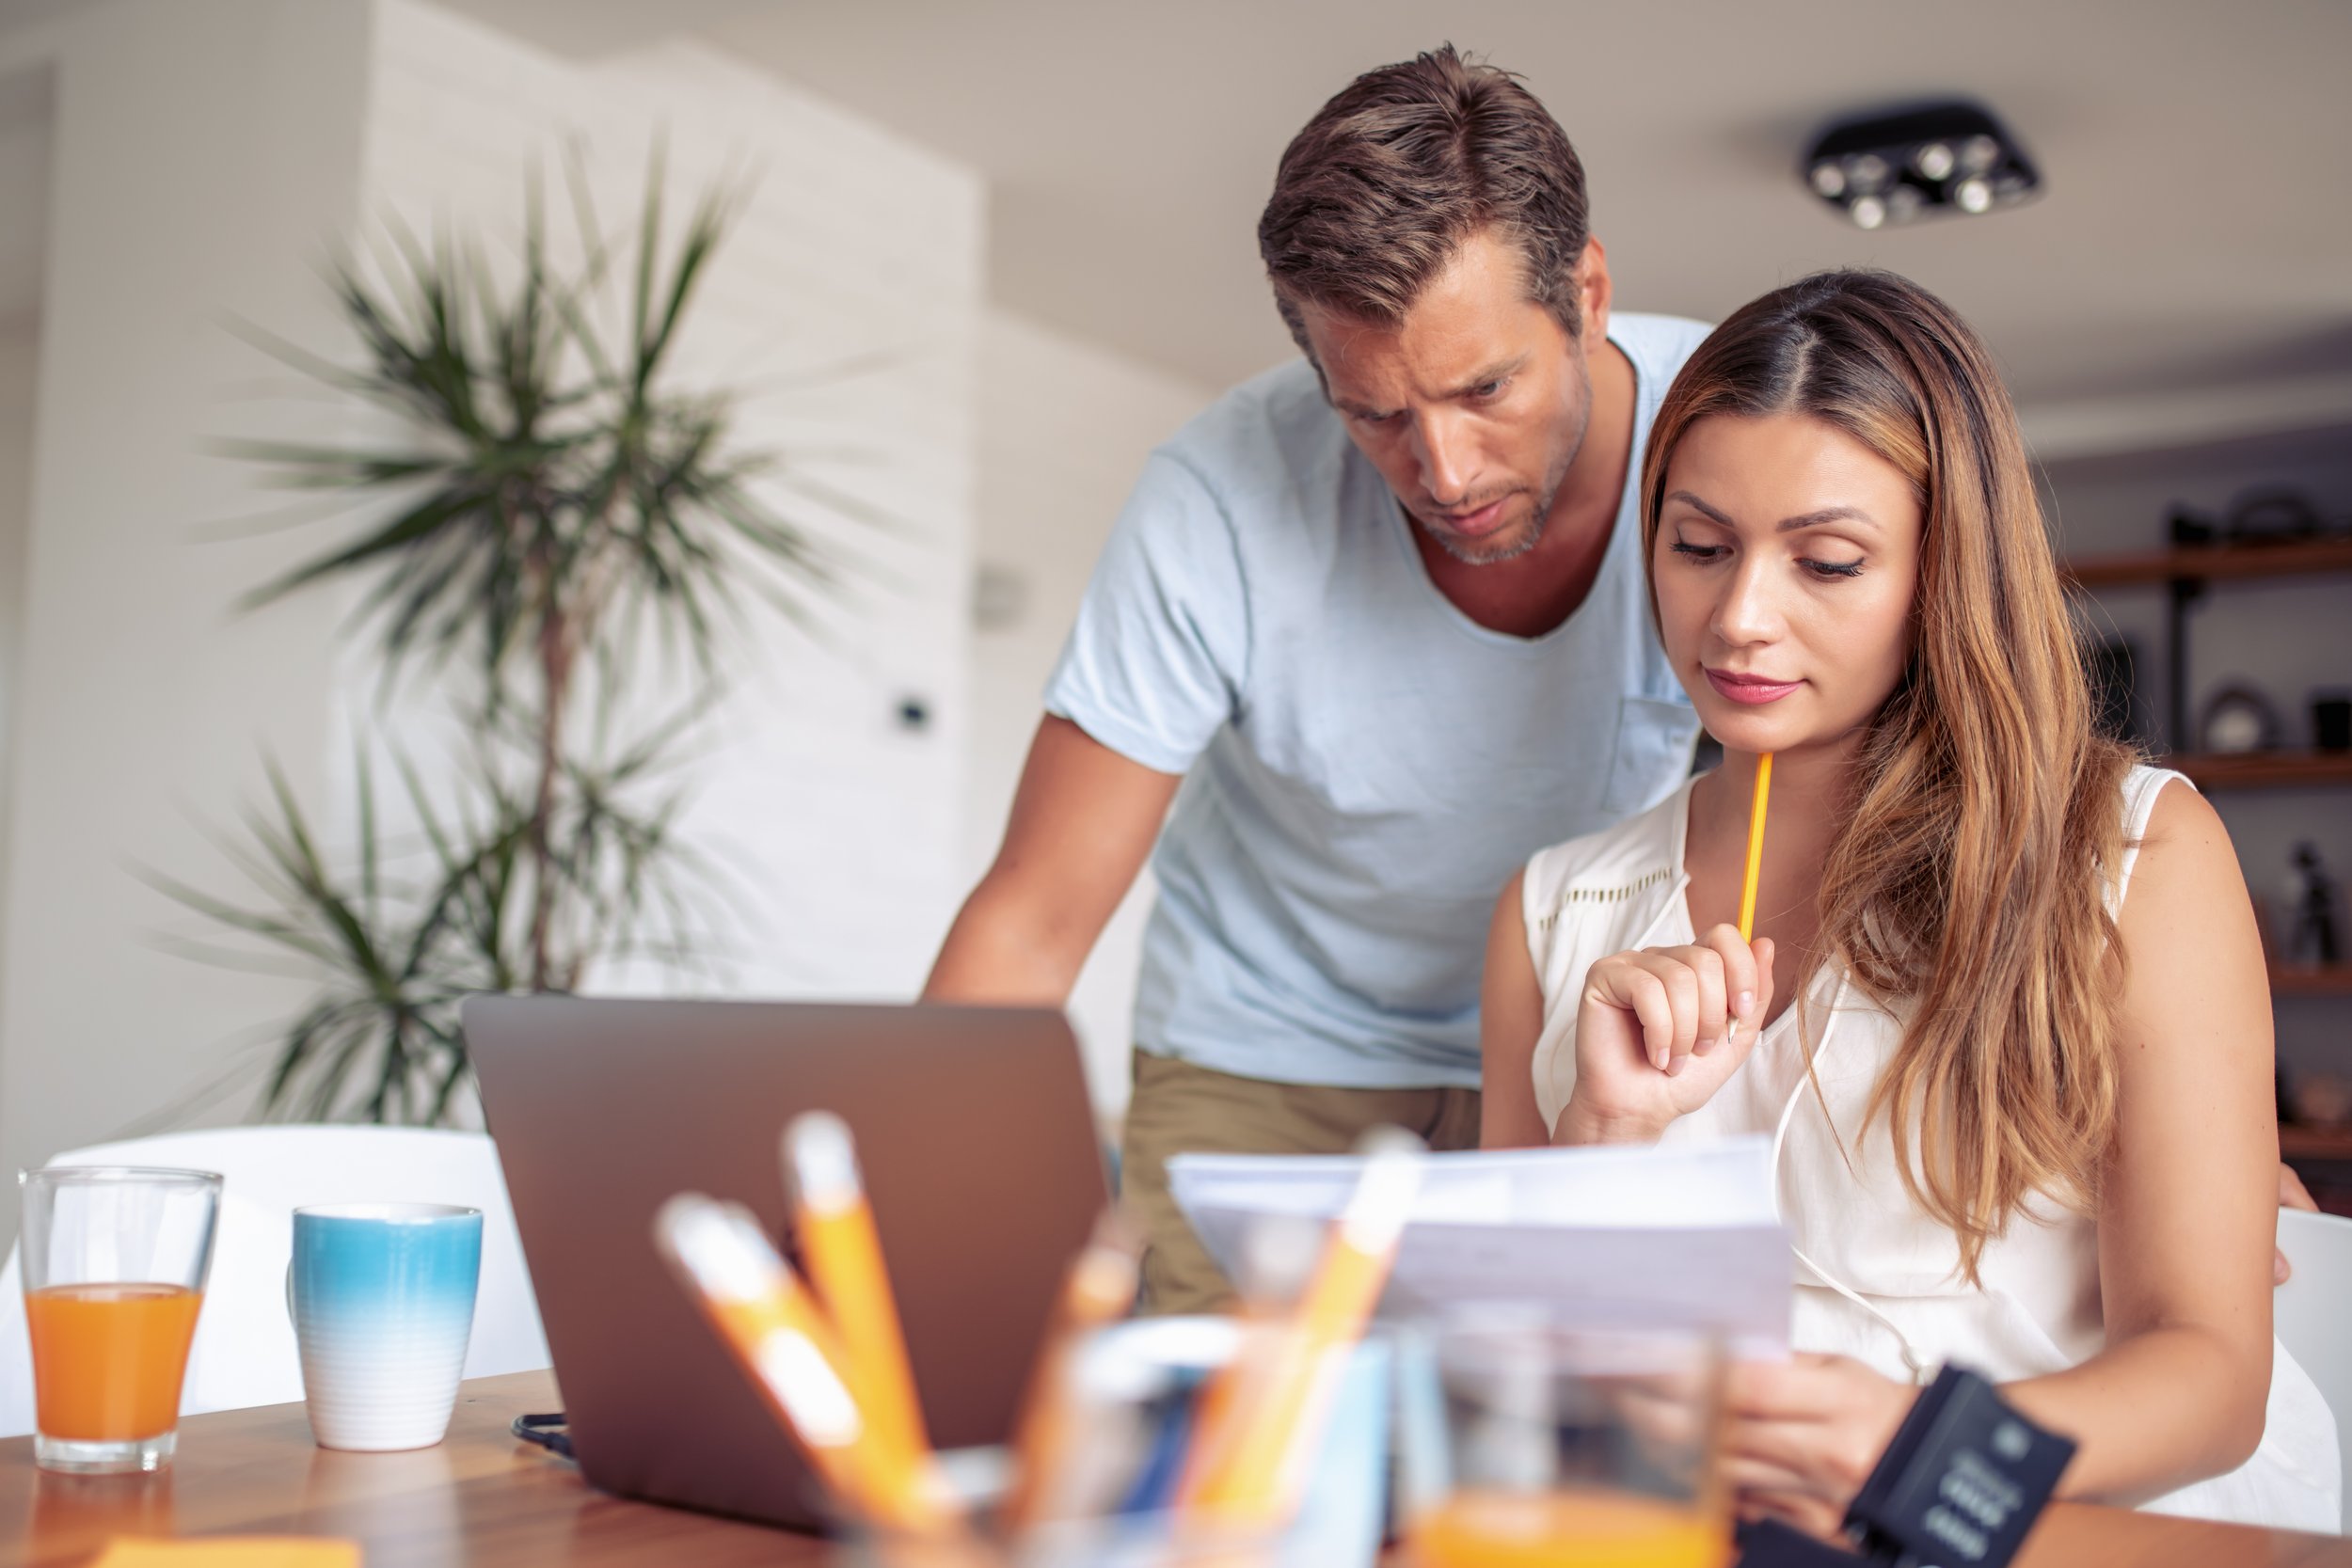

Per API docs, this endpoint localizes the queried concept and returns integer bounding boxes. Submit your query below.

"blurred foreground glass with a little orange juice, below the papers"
[1400,1309,1731,1568]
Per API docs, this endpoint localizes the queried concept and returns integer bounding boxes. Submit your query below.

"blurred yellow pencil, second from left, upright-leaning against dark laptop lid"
[784,1112,931,1465]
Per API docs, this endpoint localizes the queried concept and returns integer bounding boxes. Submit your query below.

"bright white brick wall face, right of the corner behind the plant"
[348,0,983,1020]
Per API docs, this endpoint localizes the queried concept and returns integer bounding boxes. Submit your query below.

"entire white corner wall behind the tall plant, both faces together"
[0,0,983,1212]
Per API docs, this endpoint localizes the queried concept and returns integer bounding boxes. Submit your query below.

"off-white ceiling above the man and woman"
[13,0,2352,416]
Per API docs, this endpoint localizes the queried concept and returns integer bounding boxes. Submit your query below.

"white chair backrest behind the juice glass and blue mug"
[0,1126,548,1436]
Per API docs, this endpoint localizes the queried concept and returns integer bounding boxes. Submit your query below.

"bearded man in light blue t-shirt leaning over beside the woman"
[925,47,1706,1312]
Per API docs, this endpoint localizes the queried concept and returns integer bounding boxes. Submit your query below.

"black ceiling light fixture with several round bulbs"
[1800,99,2042,228]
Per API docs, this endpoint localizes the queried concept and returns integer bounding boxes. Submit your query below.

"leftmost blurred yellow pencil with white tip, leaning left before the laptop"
[654,1192,960,1535]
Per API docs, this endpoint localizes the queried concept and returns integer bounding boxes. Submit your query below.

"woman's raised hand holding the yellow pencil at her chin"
[1552,927,1773,1143]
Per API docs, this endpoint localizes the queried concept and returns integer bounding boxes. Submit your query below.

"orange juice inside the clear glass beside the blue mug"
[24,1284,205,1444]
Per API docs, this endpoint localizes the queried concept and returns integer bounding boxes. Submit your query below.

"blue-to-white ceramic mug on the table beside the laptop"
[287,1204,483,1450]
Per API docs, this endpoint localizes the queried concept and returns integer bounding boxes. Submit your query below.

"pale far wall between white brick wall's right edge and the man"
[962,306,1214,1112]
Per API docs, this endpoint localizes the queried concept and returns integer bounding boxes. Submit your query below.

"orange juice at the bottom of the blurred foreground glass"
[1411,1491,1731,1568]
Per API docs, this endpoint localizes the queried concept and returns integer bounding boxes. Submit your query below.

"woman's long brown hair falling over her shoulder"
[1642,270,2134,1281]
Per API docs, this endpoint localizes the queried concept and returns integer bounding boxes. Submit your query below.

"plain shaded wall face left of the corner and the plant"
[0,0,367,1229]
